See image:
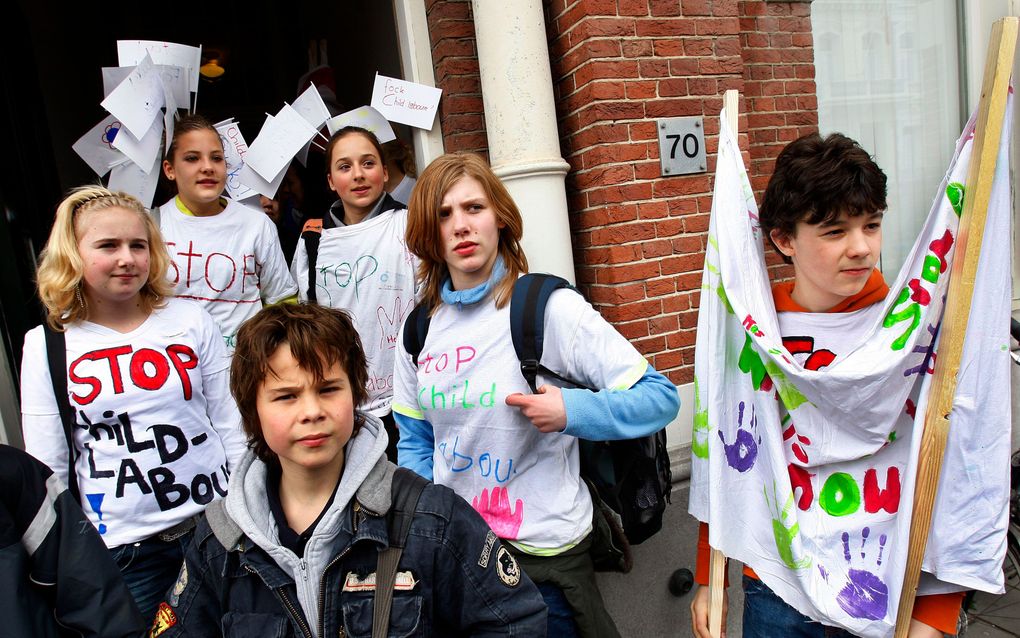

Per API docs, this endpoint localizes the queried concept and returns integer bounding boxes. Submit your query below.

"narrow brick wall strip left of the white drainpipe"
[425,0,489,154]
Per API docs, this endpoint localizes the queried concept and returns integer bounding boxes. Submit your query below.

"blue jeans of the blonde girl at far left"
[110,532,192,623]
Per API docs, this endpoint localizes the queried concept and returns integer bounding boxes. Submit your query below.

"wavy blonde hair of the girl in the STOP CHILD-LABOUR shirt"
[36,186,173,332]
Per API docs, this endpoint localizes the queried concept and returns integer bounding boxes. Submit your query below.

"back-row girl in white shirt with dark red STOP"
[159,115,298,352]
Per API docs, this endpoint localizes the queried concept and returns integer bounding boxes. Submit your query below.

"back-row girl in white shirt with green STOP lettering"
[291,127,416,461]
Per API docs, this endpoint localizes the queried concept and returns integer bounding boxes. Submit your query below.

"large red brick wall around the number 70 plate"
[546,0,817,384]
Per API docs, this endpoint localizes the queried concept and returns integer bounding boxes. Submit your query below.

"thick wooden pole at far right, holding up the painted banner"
[896,17,1020,638]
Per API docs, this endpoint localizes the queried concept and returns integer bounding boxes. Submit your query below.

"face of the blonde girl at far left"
[74,207,149,303]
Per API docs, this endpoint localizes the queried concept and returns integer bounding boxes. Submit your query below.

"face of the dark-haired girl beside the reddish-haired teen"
[326,133,388,217]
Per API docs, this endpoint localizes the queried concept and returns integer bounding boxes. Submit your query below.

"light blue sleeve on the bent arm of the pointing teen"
[563,365,680,443]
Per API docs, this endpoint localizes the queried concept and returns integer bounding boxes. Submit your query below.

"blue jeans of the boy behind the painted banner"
[744,576,853,638]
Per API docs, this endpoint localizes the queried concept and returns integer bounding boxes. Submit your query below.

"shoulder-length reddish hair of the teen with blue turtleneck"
[405,151,527,311]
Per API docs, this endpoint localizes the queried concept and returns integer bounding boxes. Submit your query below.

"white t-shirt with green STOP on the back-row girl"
[291,208,417,416]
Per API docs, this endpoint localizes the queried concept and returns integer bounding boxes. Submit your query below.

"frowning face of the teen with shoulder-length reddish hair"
[440,176,506,290]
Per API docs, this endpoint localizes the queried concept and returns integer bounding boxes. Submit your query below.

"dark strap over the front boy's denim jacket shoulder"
[372,468,428,638]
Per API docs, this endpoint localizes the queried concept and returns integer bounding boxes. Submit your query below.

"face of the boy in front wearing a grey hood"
[255,343,354,476]
